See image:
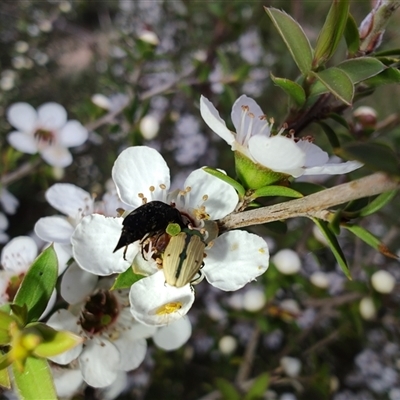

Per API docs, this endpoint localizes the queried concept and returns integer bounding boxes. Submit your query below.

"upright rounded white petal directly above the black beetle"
[112,146,170,207]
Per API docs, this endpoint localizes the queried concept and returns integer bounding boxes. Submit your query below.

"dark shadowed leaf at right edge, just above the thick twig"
[335,142,400,176]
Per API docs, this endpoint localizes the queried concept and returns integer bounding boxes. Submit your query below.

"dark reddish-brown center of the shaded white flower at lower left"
[80,289,119,334]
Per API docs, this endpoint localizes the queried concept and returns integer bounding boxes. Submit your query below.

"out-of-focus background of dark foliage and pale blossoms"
[0,0,400,400]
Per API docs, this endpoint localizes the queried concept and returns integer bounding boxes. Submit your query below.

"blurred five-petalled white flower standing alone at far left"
[7,103,88,167]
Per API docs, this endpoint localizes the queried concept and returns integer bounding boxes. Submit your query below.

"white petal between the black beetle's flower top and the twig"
[185,169,239,220]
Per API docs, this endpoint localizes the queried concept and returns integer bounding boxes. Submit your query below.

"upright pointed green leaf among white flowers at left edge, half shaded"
[14,246,58,322]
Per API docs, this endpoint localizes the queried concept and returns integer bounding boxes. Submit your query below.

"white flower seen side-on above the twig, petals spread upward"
[200,95,362,178]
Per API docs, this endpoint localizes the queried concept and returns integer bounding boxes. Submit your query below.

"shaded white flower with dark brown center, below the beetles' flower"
[48,278,155,387]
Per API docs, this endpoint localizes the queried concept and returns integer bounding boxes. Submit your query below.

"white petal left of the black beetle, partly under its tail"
[71,214,139,276]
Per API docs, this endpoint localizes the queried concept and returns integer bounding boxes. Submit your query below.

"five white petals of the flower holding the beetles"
[72,146,269,325]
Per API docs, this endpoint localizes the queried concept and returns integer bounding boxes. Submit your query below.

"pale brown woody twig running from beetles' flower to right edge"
[219,172,400,231]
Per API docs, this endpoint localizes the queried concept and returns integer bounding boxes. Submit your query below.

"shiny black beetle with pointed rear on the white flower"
[113,200,186,259]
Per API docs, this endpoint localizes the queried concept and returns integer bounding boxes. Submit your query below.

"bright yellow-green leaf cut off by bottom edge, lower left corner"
[12,357,57,400]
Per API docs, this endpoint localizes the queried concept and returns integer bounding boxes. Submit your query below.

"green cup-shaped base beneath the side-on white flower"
[234,151,290,189]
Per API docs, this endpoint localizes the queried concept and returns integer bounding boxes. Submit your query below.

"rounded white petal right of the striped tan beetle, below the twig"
[202,231,269,291]
